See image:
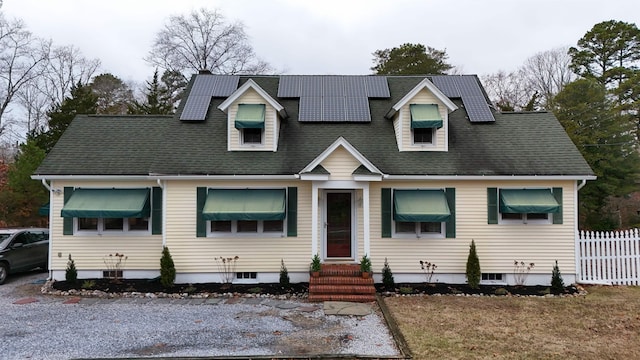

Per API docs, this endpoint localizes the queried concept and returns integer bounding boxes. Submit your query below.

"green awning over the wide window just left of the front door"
[202,189,286,221]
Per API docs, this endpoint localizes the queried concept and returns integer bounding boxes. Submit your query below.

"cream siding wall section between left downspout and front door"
[166,181,311,274]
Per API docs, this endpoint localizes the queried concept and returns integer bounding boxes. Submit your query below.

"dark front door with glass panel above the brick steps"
[325,191,353,258]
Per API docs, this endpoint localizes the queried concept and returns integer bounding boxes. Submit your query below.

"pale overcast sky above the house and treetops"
[2,0,640,82]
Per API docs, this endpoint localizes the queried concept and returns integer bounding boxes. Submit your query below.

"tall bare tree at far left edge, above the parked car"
[0,13,50,134]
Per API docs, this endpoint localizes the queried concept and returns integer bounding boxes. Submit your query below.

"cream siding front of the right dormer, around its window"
[394,89,449,151]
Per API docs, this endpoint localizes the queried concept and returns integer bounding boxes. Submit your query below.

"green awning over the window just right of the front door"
[393,190,451,222]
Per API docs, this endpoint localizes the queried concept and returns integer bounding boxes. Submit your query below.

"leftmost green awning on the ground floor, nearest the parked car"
[61,189,151,218]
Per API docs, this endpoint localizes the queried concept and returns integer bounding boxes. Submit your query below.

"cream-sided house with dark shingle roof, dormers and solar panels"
[33,72,595,290]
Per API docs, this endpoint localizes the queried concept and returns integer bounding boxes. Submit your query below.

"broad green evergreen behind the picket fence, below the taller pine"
[553,79,640,230]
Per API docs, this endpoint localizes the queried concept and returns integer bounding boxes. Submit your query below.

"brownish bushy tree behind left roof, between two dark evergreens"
[89,74,134,115]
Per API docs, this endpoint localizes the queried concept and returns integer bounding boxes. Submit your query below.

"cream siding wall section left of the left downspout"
[50,181,162,270]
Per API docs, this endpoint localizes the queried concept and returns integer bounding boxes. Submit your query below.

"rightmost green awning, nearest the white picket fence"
[500,189,560,214]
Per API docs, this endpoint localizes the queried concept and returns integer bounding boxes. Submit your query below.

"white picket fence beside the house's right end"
[576,229,640,285]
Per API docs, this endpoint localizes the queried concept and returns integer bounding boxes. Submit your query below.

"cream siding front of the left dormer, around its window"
[227,89,278,151]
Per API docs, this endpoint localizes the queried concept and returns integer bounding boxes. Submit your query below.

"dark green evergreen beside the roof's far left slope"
[29,83,98,153]
